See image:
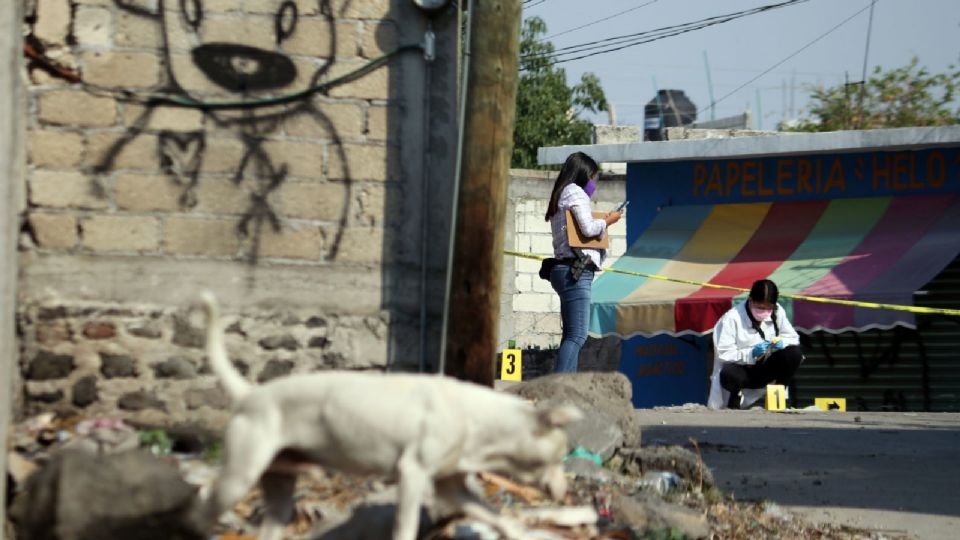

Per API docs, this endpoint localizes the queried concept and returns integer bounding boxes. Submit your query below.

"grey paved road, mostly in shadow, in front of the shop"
[637,406,960,539]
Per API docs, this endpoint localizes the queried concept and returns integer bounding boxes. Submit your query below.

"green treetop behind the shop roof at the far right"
[786,57,960,131]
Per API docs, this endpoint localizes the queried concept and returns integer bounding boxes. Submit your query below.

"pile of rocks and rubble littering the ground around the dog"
[7,374,912,540]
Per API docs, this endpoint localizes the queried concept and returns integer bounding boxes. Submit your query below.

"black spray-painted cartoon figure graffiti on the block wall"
[93,0,352,260]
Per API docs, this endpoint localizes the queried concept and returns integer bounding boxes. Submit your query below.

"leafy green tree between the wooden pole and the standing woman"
[511,17,607,169]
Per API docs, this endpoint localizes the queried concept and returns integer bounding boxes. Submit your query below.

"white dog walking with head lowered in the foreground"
[203,293,581,540]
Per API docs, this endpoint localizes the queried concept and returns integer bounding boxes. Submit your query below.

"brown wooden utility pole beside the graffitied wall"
[443,0,521,386]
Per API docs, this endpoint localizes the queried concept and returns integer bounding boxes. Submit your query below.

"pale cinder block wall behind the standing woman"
[498,169,627,349]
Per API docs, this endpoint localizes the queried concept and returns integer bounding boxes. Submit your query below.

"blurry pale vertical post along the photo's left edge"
[0,2,24,540]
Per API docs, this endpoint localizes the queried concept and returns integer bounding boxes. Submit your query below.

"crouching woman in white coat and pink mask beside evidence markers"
[707,279,803,409]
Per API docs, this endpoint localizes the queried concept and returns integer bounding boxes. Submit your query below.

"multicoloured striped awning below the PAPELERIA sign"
[590,193,960,337]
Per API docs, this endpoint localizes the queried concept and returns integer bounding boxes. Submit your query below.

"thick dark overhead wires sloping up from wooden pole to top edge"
[521,0,809,64]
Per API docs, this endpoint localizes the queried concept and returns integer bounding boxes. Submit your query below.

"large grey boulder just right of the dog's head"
[506,372,640,448]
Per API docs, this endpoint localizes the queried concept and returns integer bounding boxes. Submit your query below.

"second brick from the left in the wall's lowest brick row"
[80,215,160,252]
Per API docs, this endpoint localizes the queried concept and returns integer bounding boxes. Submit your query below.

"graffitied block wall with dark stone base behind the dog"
[17,0,458,423]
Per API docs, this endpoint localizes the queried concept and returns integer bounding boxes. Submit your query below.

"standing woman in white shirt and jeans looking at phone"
[545,152,621,373]
